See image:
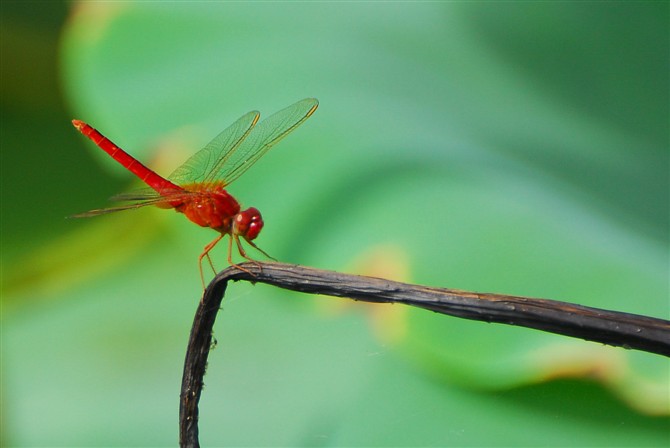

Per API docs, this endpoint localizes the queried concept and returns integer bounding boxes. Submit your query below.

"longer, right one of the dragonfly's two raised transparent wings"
[205,98,319,185]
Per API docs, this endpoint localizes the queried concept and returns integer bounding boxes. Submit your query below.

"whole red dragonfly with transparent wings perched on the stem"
[72,98,319,287]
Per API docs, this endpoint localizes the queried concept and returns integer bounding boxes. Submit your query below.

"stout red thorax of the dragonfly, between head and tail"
[175,184,240,233]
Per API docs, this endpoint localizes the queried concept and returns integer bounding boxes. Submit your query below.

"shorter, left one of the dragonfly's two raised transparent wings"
[168,111,260,185]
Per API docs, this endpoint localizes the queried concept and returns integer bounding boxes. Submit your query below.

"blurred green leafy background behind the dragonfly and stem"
[0,2,670,446]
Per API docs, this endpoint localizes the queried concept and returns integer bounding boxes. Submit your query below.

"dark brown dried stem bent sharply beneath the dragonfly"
[179,262,670,447]
